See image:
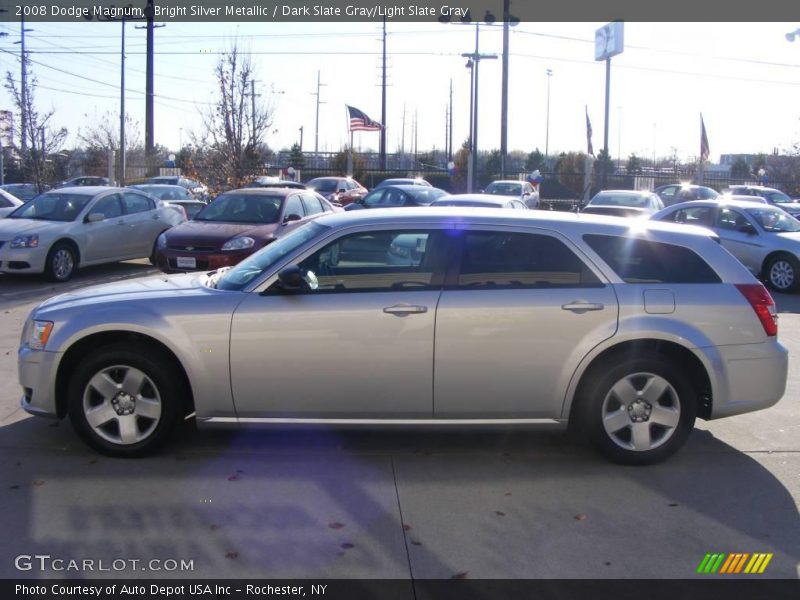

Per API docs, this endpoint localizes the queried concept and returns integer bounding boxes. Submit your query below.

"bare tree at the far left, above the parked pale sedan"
[5,57,67,190]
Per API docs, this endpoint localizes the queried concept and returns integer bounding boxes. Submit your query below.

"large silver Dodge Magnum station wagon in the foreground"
[19,208,787,464]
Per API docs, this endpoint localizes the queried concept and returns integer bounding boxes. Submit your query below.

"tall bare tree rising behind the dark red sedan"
[193,43,273,187]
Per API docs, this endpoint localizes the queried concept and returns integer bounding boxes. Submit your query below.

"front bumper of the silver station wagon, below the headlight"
[17,347,62,418]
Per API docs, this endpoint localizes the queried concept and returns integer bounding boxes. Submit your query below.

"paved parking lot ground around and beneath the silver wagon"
[0,261,800,579]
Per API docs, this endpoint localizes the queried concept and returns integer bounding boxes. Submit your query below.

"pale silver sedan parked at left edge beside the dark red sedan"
[0,186,185,281]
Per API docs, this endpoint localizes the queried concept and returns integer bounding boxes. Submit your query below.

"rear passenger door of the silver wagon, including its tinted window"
[434,232,618,418]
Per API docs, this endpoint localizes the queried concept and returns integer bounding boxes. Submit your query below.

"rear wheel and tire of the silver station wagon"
[577,353,697,465]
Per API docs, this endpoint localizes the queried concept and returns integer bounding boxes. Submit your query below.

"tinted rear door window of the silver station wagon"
[457,231,602,289]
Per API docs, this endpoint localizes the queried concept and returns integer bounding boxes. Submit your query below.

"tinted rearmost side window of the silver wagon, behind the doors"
[583,234,721,283]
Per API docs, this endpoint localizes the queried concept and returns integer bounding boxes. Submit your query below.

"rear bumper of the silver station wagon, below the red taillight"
[711,340,789,419]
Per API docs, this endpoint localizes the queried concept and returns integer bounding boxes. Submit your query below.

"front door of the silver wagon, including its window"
[230,229,447,418]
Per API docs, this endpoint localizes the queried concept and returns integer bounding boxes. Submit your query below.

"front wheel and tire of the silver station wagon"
[67,343,186,457]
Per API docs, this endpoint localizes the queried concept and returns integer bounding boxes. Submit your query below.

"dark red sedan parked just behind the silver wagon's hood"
[156,188,342,273]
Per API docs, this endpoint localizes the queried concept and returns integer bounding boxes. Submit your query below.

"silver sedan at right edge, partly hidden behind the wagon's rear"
[651,198,800,292]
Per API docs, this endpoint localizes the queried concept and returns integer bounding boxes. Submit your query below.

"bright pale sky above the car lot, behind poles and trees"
[0,22,800,161]
